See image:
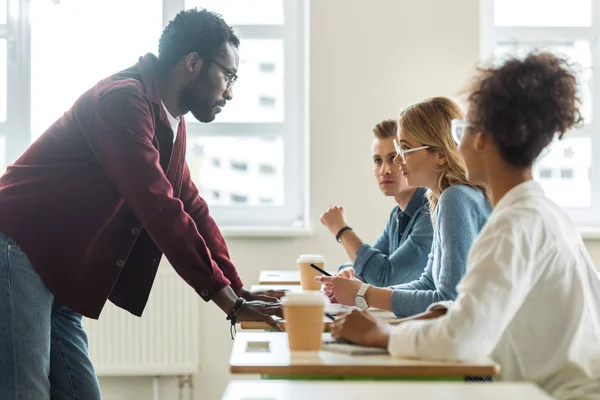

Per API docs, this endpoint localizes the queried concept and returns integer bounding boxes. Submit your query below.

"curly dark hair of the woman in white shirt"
[468,51,582,167]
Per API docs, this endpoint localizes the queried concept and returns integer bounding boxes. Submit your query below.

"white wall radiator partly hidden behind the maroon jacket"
[83,266,202,376]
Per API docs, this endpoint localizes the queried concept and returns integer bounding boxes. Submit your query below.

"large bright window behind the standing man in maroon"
[5,0,308,228]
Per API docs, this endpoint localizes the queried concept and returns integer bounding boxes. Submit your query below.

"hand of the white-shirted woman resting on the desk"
[330,310,390,348]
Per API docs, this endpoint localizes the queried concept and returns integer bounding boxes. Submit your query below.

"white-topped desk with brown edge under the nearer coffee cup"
[229,332,500,379]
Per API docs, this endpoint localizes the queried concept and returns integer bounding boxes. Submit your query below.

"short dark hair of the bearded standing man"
[158,8,240,71]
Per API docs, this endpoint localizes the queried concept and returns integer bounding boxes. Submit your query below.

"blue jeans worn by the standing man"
[0,233,101,400]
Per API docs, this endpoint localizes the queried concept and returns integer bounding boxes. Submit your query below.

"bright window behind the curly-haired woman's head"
[480,0,600,227]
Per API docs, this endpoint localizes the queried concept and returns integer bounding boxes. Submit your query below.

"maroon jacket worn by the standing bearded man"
[0,54,242,318]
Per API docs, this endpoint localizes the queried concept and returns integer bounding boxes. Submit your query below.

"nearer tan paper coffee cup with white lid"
[281,291,329,351]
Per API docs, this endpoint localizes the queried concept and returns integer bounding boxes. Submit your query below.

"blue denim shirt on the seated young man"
[354,188,433,287]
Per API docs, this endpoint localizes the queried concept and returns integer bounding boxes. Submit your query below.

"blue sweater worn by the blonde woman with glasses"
[392,185,492,317]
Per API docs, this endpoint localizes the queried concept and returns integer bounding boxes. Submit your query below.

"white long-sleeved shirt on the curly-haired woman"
[389,181,600,400]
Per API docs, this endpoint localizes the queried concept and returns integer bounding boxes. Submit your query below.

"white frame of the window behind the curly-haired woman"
[479,0,600,227]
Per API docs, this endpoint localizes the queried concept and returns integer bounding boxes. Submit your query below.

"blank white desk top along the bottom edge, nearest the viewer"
[221,380,552,400]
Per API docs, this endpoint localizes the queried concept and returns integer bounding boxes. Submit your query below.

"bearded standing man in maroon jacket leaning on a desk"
[0,10,281,400]
